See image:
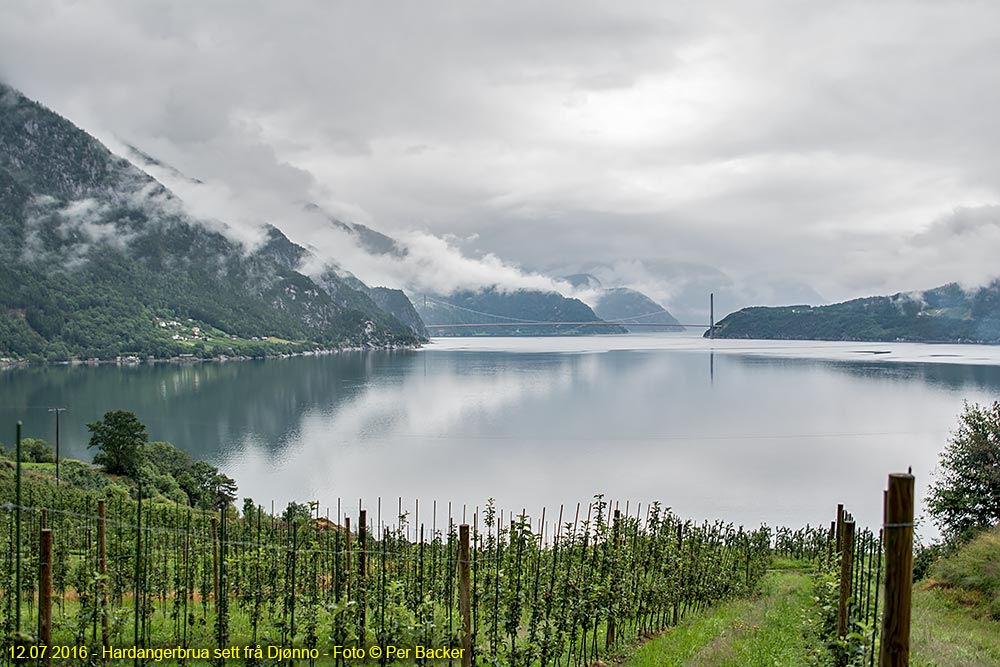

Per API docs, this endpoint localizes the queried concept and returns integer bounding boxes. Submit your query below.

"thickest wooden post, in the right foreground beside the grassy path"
[879,473,913,667]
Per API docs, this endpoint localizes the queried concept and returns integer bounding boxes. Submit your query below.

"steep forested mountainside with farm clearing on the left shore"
[0,84,419,359]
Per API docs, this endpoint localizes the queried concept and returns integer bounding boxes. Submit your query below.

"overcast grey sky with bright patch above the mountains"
[0,0,1000,299]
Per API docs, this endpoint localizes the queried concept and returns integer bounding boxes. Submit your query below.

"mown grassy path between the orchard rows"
[625,570,812,667]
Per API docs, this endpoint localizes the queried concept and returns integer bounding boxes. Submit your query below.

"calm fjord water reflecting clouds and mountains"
[0,334,1000,535]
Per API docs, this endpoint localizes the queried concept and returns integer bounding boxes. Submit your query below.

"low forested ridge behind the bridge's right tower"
[706,280,1000,344]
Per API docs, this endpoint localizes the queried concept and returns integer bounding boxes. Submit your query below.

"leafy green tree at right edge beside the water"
[927,402,1000,541]
